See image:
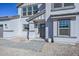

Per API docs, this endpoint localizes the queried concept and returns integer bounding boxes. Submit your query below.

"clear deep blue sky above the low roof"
[0,3,17,16]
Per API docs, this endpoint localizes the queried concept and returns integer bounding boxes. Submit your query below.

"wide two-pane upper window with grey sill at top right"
[51,3,75,10]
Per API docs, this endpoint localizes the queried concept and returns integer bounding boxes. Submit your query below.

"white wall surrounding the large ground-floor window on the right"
[50,3,79,43]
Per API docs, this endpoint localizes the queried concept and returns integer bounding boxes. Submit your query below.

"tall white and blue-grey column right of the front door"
[45,3,53,41]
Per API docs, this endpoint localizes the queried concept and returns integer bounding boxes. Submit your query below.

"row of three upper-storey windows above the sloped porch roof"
[22,4,38,16]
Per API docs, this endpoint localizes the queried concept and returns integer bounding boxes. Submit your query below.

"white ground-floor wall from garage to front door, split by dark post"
[0,18,28,39]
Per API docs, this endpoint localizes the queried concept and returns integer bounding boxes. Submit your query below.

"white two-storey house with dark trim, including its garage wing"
[0,3,79,43]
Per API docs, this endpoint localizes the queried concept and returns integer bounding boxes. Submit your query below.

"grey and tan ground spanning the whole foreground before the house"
[0,40,79,56]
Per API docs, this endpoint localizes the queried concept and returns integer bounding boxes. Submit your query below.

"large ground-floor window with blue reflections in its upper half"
[59,19,70,36]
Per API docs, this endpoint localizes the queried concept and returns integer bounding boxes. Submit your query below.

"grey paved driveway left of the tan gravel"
[0,40,45,52]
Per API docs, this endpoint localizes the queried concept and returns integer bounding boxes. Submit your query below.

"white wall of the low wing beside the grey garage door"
[0,19,17,38]
